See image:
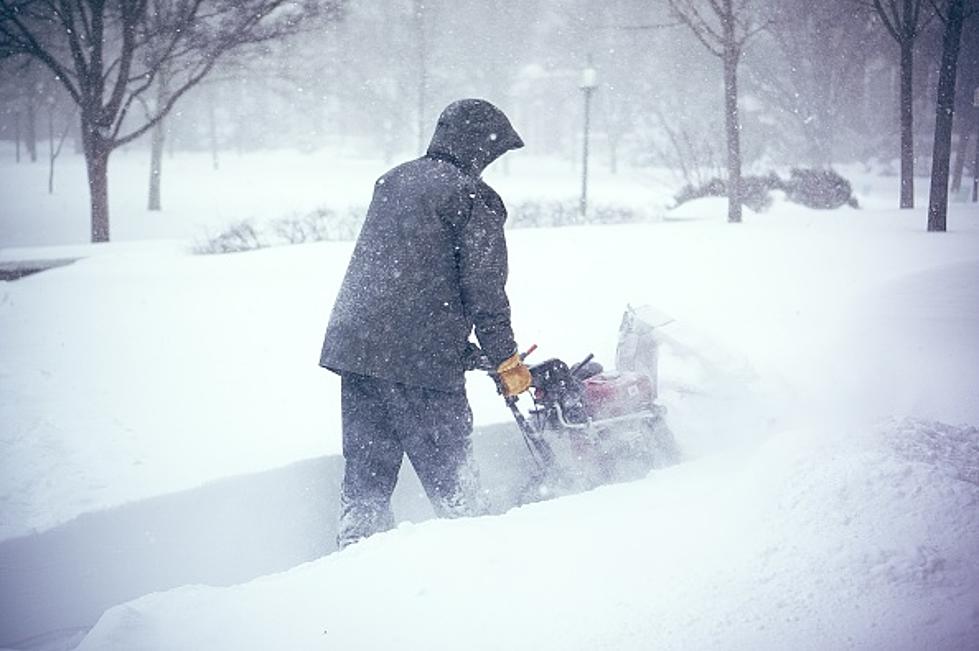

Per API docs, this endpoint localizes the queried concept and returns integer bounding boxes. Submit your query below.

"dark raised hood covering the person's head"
[428,99,523,176]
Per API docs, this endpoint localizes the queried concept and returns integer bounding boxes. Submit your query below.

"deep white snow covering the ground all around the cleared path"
[0,152,979,649]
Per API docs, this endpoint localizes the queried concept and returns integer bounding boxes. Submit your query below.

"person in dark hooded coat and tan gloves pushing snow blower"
[320,99,530,549]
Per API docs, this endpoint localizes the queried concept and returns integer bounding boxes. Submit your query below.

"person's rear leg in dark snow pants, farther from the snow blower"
[337,373,404,549]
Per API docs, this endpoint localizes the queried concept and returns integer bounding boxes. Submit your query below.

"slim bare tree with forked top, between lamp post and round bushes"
[669,0,764,223]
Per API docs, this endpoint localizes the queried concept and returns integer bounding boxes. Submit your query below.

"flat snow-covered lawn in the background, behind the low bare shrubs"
[0,143,670,248]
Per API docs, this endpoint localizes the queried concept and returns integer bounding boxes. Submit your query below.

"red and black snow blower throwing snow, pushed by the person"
[473,307,680,502]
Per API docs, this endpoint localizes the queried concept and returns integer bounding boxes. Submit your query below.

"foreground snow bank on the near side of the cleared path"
[79,421,979,650]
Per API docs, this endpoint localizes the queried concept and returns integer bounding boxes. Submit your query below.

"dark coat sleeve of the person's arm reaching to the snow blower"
[458,184,517,366]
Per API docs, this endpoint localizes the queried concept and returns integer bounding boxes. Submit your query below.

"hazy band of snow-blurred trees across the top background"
[0,0,979,239]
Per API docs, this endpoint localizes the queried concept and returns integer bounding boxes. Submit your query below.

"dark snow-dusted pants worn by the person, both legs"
[337,373,486,549]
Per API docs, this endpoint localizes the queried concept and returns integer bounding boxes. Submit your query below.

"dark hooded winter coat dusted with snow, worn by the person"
[320,99,523,391]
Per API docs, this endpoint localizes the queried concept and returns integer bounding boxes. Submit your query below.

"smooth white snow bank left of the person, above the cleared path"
[0,244,350,538]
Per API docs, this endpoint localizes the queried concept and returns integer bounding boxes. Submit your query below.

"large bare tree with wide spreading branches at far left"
[0,0,339,242]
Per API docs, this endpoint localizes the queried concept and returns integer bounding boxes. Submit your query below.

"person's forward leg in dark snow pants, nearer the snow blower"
[388,385,488,518]
